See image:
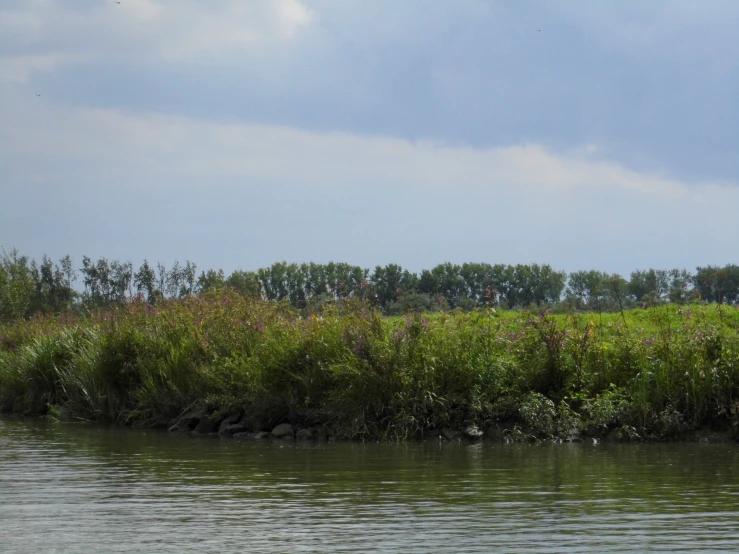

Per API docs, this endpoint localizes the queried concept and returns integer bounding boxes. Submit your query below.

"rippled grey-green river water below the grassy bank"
[0,419,739,554]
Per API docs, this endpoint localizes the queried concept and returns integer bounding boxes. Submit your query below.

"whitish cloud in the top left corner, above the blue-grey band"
[0,0,315,78]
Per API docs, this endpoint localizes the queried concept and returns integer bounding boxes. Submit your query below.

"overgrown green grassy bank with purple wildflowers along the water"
[0,291,739,439]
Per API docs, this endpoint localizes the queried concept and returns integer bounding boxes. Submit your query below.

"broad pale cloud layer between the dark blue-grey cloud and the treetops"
[0,94,739,274]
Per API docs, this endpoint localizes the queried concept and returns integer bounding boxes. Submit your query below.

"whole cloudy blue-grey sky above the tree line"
[0,0,739,276]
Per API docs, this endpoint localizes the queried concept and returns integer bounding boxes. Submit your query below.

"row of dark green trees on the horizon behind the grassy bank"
[0,249,739,321]
